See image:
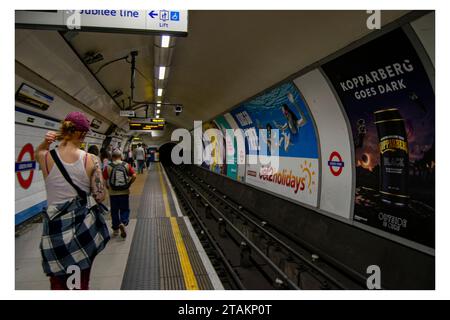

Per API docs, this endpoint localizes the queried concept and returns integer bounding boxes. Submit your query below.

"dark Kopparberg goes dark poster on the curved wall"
[323,29,435,247]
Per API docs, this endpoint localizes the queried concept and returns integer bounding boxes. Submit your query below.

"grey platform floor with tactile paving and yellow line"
[15,163,223,290]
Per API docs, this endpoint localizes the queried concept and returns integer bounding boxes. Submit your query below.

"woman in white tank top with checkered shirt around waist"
[35,112,109,290]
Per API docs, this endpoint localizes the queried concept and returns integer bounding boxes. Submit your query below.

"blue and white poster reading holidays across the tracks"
[231,83,320,206]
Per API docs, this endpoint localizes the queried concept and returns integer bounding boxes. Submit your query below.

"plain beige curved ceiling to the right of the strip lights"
[167,11,407,128]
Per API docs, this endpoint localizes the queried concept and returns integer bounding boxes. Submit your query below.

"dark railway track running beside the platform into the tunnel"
[166,166,363,290]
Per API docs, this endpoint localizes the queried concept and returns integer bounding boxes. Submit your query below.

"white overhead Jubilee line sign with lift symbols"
[15,10,188,36]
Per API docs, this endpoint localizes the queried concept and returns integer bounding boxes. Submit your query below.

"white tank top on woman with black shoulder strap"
[45,148,91,206]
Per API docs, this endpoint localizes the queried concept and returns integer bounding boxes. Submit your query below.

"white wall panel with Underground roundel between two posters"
[294,69,353,219]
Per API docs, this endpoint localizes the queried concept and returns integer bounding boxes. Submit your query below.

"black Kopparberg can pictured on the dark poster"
[374,108,409,206]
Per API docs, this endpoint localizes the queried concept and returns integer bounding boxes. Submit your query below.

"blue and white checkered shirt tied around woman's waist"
[40,197,110,276]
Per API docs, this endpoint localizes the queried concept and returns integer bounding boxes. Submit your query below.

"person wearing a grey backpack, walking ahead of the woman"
[103,149,136,238]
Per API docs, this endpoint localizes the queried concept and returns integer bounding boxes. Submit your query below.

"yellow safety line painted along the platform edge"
[158,163,199,290]
